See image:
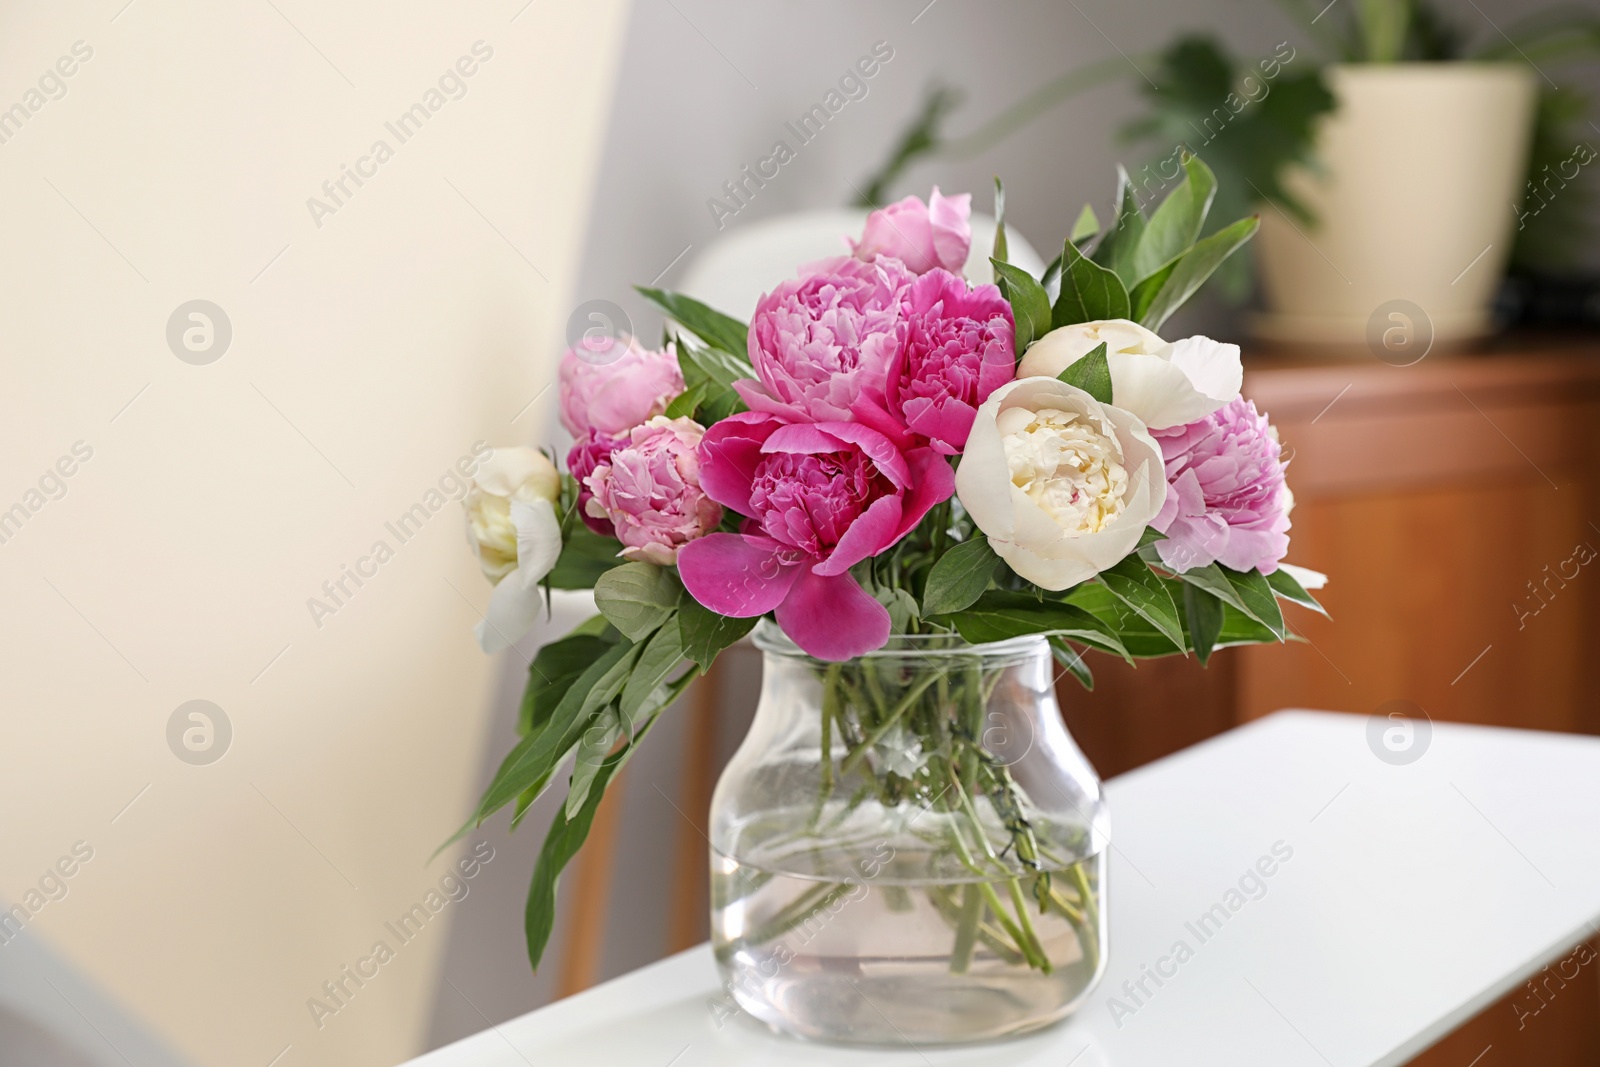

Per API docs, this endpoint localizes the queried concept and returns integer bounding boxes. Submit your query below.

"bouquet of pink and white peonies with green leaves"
[462,158,1320,965]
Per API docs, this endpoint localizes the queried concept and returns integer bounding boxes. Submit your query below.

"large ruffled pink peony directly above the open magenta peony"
[733,256,912,422]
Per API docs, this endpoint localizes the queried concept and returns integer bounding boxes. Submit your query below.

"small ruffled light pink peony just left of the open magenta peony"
[586,416,722,566]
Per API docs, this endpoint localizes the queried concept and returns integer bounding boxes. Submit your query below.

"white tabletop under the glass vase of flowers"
[413,712,1600,1067]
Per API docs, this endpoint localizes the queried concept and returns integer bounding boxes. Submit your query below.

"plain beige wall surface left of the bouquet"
[0,0,626,1067]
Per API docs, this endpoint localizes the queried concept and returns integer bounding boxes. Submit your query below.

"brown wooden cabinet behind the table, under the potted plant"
[1061,339,1600,1067]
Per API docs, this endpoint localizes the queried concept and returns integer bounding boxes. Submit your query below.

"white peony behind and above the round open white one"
[1016,318,1245,430]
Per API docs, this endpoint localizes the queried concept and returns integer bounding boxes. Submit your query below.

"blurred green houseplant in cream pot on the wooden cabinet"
[866,0,1600,342]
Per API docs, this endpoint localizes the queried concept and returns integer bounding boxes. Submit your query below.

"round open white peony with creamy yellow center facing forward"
[955,377,1166,590]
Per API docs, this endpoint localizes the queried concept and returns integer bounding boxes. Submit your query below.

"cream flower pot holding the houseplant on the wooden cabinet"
[1254,62,1538,344]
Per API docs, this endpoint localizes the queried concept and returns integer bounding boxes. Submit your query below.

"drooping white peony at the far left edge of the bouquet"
[462,446,562,653]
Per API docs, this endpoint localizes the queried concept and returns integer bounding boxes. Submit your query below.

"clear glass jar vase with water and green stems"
[710,622,1110,1045]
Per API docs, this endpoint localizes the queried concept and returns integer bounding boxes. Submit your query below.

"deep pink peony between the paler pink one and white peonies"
[856,269,1016,456]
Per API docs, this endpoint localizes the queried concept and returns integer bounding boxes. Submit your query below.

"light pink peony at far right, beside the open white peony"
[1150,397,1294,574]
